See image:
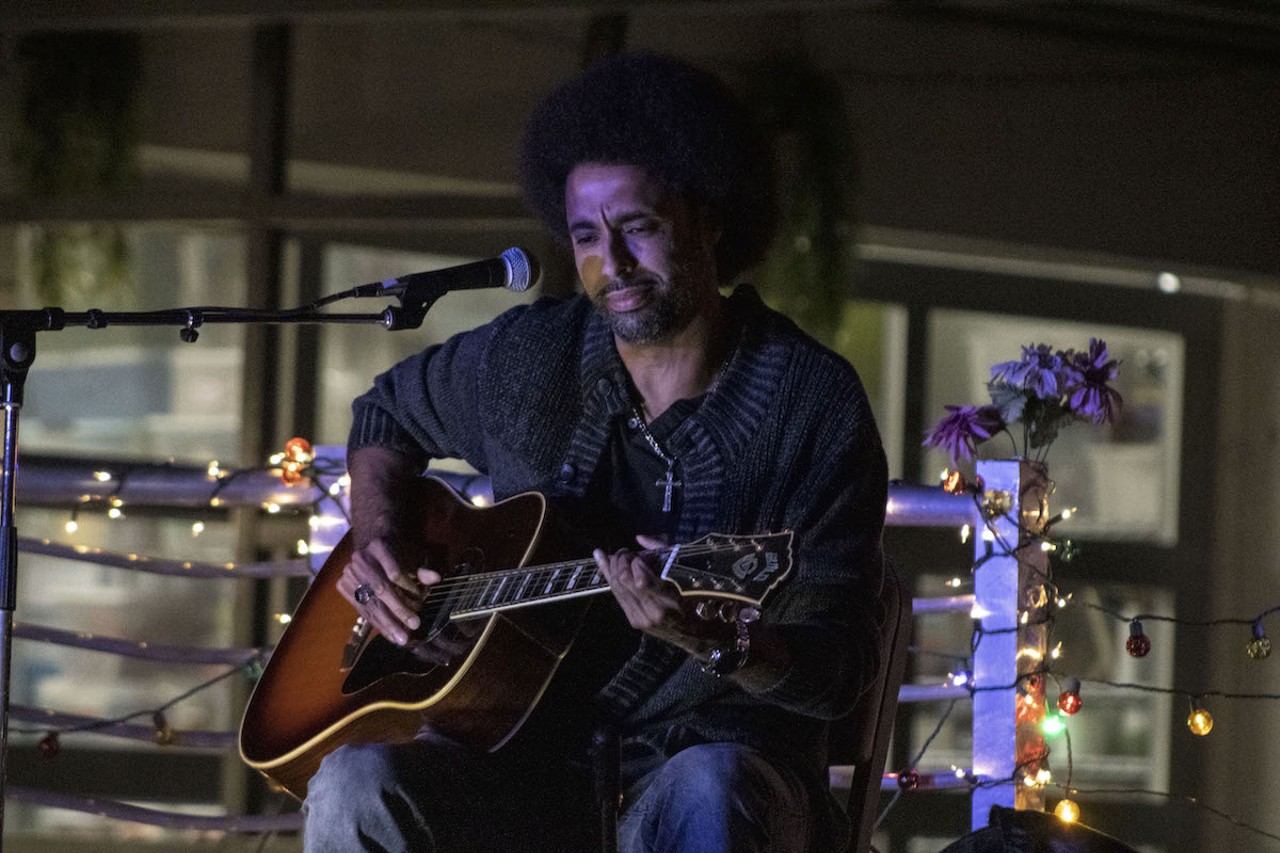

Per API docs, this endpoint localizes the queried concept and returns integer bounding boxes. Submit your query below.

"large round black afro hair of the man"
[520,53,777,283]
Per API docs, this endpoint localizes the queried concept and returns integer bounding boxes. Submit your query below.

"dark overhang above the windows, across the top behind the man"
[0,0,1280,286]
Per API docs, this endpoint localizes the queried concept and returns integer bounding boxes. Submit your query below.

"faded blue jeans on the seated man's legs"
[303,736,813,853]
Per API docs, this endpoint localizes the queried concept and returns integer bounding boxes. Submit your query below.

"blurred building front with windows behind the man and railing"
[0,0,1280,853]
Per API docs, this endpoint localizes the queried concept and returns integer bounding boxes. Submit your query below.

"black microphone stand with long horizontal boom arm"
[0,274,463,853]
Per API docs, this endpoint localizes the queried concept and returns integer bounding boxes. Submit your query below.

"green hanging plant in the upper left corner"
[12,32,142,304]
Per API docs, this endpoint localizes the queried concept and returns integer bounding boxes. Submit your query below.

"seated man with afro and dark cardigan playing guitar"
[306,55,886,853]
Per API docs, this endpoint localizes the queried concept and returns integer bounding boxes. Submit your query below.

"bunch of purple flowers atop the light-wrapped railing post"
[924,338,1123,465]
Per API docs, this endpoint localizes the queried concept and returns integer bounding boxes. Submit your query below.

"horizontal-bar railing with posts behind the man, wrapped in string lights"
[8,448,1044,833]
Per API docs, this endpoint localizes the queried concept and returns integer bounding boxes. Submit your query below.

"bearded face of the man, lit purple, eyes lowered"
[564,163,719,345]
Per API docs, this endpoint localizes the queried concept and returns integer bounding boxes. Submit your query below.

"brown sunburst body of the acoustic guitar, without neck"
[239,478,584,799]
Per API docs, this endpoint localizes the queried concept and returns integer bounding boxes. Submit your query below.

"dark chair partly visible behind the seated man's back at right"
[827,565,911,853]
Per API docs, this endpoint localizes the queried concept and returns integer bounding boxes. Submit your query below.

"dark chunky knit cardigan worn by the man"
[349,280,887,792]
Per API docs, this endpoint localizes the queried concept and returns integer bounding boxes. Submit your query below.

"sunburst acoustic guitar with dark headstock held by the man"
[239,478,791,799]
